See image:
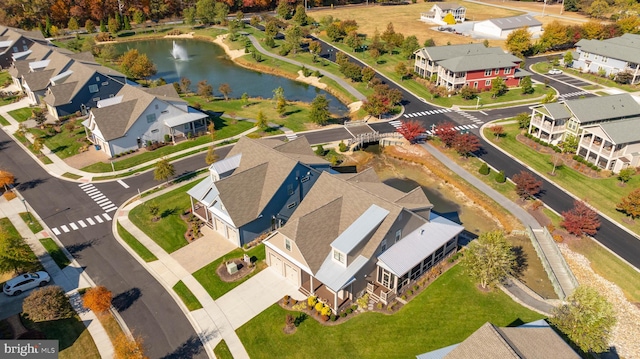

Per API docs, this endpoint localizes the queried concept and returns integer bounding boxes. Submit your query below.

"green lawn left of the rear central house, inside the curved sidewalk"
[129,181,198,253]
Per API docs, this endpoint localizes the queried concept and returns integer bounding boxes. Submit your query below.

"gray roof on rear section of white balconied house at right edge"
[565,94,640,124]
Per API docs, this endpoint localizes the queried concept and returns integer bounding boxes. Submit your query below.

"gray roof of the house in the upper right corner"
[576,34,640,63]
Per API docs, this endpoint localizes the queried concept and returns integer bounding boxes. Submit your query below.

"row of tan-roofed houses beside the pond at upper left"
[0,27,208,157]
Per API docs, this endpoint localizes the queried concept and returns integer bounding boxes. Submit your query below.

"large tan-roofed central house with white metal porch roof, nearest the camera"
[263,169,464,313]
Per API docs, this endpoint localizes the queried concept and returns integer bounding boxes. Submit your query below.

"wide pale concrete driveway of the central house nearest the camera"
[216,268,306,330]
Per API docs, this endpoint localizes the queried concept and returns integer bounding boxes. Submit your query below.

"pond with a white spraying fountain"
[115,39,348,116]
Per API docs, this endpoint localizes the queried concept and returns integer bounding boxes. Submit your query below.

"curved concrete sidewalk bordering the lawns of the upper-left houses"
[0,98,257,183]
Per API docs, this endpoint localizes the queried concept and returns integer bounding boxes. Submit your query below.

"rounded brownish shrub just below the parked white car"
[22,285,74,322]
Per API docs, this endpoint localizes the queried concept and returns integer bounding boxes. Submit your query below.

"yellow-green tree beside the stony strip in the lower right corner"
[549,286,616,353]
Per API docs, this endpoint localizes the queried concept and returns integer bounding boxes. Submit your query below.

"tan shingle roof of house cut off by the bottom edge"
[416,319,580,359]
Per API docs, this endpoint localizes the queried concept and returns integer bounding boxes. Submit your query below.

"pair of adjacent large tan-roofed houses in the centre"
[188,137,464,312]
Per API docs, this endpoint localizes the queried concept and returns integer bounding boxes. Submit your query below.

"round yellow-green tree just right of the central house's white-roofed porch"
[462,231,517,288]
